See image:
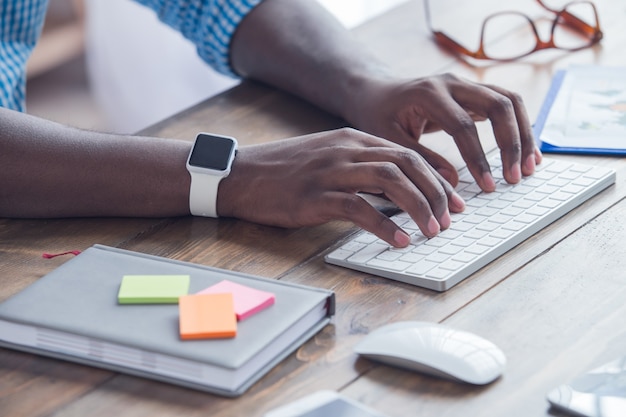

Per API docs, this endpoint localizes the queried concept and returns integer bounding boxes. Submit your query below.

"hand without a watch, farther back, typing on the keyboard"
[350,74,541,191]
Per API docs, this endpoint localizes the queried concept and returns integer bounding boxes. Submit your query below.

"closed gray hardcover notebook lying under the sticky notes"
[0,245,334,396]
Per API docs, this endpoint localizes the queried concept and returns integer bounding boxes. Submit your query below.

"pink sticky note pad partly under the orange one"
[197,280,276,320]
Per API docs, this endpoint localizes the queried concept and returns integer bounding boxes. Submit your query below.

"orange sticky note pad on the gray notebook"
[178,293,237,340]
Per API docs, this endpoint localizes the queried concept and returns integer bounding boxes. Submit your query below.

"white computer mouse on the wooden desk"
[354,321,506,385]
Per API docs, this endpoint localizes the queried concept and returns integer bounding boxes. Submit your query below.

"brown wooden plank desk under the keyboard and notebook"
[0,0,626,417]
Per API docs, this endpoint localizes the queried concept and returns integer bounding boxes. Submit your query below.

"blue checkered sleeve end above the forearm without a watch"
[136,0,262,77]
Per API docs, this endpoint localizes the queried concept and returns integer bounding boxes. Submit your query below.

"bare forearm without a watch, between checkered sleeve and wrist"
[231,0,388,127]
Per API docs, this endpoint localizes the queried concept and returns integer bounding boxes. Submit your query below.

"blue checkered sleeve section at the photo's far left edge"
[0,0,48,111]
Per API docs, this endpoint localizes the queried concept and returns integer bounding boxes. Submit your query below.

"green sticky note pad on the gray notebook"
[117,275,189,304]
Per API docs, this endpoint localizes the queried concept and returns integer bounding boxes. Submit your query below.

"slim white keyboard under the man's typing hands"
[325,157,615,291]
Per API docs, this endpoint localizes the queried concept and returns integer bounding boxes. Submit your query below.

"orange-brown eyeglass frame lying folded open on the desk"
[423,0,604,62]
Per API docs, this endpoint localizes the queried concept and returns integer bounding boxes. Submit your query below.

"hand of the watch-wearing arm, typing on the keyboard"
[217,129,464,247]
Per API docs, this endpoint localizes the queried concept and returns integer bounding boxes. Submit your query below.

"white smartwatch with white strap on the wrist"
[187,133,237,217]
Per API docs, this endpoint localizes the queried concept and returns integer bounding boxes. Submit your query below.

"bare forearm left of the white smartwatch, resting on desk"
[0,108,191,217]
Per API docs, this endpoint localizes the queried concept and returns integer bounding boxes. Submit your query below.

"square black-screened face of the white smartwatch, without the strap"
[189,134,235,171]
